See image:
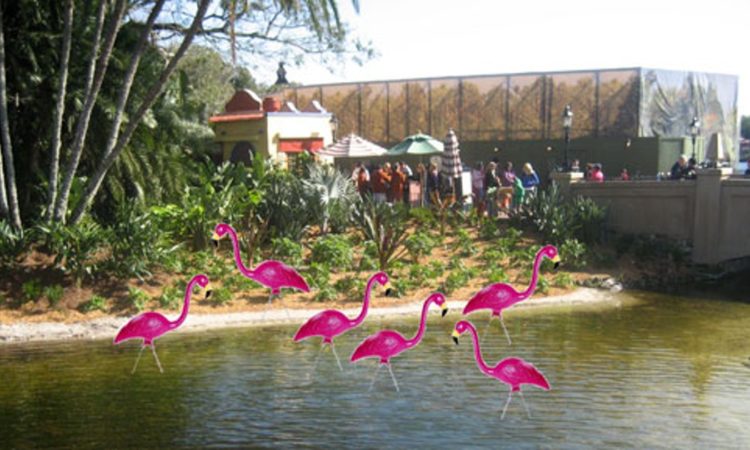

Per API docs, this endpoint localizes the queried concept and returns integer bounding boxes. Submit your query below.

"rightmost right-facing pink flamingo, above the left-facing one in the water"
[463,245,560,345]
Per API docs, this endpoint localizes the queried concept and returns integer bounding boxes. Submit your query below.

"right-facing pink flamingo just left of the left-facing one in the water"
[350,292,448,392]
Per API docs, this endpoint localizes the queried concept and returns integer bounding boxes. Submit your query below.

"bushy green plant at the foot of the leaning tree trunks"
[39,220,110,286]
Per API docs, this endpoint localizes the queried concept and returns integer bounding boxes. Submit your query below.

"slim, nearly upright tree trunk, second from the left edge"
[45,0,74,222]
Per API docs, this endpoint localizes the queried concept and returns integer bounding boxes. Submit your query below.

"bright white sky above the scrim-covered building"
[276,0,750,115]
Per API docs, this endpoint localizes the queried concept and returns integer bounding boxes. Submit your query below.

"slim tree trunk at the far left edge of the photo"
[0,4,21,230]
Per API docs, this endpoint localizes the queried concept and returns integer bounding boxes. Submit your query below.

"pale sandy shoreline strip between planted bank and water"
[0,288,618,345]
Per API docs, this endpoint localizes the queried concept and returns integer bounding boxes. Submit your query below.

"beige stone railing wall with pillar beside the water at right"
[552,169,750,264]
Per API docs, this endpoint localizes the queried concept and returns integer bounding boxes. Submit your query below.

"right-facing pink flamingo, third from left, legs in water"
[294,272,388,372]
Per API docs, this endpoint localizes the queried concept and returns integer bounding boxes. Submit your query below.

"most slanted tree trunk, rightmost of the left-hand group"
[71,0,210,224]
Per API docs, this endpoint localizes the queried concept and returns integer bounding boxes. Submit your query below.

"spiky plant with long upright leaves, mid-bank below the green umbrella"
[353,196,409,270]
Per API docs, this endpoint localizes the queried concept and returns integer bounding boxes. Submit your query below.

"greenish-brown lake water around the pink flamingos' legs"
[0,293,750,448]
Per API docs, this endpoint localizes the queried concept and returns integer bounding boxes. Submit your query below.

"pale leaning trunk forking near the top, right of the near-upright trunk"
[54,0,127,222]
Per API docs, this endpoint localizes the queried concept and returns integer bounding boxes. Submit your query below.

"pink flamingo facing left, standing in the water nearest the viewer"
[453,320,551,420]
